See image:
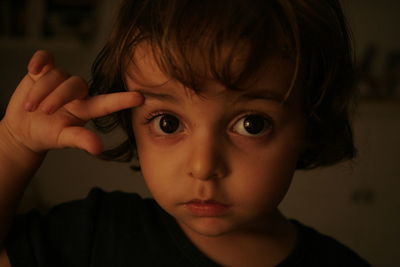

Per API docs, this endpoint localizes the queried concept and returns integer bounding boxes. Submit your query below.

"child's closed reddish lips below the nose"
[185,201,229,217]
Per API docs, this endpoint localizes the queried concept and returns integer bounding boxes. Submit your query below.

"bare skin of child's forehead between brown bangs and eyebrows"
[125,43,294,102]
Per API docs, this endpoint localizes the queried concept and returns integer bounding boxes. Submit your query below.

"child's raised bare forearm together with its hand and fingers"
[0,51,143,248]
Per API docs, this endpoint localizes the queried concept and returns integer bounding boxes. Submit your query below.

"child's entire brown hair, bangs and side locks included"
[90,0,355,169]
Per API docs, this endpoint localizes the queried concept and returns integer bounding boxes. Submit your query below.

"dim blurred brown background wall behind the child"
[0,0,400,267]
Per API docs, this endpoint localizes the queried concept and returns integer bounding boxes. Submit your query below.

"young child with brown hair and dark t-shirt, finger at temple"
[0,0,368,267]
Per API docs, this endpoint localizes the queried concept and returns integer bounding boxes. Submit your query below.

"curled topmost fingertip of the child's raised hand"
[28,50,54,82]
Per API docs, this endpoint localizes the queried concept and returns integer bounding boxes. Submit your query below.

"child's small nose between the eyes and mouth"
[187,134,229,180]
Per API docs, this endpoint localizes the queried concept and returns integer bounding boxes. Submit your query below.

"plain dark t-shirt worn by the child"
[5,189,369,267]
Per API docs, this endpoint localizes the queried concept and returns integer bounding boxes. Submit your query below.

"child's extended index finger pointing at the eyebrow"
[65,92,144,121]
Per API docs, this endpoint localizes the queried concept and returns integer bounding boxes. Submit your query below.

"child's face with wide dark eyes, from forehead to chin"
[126,45,305,239]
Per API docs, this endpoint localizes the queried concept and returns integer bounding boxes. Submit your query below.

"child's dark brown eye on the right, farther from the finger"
[233,115,271,136]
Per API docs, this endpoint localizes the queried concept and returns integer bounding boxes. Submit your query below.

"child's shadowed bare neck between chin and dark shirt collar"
[181,211,296,267]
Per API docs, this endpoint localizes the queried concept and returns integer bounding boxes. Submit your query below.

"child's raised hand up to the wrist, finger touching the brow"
[0,51,143,155]
